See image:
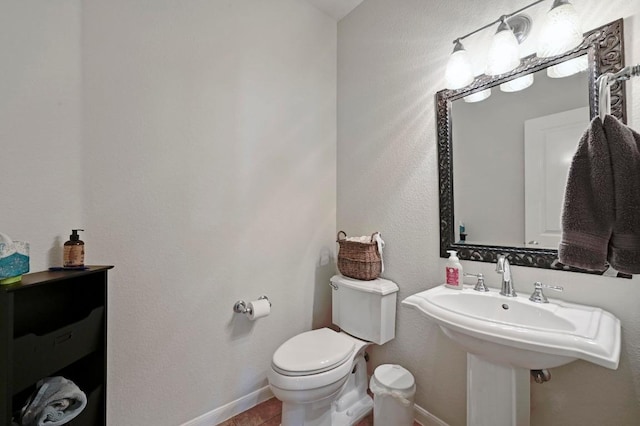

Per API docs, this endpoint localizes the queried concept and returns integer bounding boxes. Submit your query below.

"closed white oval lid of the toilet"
[273,328,355,376]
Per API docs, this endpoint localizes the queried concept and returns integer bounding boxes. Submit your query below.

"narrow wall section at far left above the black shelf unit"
[0,0,84,271]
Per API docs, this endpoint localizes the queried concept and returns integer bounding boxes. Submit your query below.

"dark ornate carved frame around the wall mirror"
[436,19,626,272]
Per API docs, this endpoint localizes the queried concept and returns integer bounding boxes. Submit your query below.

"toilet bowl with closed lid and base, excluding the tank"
[267,328,373,426]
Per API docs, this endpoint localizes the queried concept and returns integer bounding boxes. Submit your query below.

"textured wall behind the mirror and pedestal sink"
[338,0,640,425]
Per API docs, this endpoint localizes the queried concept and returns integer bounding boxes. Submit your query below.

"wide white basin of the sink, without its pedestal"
[402,285,620,370]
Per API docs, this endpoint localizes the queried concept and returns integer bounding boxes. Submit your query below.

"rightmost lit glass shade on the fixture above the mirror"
[538,0,583,58]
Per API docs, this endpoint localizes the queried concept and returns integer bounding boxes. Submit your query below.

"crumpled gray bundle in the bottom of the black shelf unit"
[21,376,87,426]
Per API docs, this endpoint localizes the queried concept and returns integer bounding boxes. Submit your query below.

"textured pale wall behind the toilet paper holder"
[82,0,336,426]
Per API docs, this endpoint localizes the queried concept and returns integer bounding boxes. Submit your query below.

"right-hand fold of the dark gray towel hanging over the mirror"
[604,115,640,274]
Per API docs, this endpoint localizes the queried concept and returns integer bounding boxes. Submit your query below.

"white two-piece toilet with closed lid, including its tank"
[267,275,398,426]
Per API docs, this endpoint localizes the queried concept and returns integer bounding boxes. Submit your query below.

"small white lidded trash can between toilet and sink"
[369,364,416,426]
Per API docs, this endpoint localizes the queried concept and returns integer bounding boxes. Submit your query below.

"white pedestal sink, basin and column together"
[402,285,620,426]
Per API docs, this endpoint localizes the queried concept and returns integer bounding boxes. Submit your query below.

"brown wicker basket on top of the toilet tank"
[336,231,382,281]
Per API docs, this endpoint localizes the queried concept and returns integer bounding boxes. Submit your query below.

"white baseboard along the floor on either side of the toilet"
[182,386,449,426]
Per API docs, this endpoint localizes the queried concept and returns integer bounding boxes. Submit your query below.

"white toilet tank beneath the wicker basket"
[331,275,399,345]
